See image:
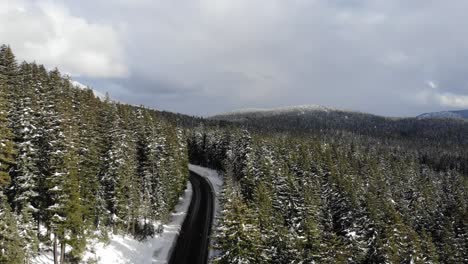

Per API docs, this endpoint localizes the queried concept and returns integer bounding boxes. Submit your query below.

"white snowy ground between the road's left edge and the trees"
[31,183,192,264]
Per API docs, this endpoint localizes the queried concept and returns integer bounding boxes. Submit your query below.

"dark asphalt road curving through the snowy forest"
[169,172,214,264]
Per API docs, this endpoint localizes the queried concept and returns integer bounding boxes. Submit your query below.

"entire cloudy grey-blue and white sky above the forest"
[0,0,468,116]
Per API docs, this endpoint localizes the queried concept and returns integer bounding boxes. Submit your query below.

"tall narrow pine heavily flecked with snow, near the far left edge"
[9,63,39,259]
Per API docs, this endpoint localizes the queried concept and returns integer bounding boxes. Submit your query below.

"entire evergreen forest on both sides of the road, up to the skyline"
[0,45,468,264]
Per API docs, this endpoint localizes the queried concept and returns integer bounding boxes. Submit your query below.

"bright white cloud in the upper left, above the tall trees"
[0,0,128,77]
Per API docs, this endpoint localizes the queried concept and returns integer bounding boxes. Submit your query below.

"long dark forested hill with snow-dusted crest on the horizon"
[210,105,468,144]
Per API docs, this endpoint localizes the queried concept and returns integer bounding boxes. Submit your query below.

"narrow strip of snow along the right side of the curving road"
[189,164,223,258]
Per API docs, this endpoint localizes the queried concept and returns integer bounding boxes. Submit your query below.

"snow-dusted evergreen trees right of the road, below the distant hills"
[188,126,468,264]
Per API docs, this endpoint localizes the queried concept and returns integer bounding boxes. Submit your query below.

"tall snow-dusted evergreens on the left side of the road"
[0,45,188,263]
